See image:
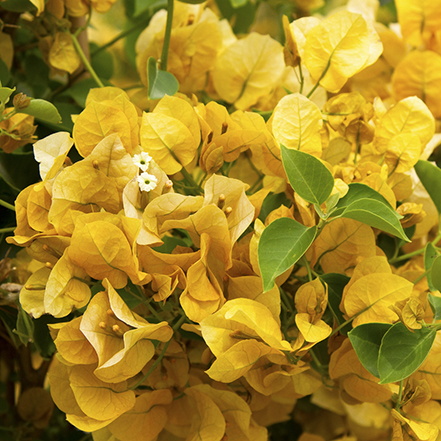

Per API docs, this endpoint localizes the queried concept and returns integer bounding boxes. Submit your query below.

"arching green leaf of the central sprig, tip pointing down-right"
[340,199,410,242]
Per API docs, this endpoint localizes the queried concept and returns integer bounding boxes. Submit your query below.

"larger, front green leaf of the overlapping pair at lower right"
[378,323,436,384]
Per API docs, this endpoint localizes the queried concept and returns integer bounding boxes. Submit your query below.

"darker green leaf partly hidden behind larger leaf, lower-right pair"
[348,323,392,378]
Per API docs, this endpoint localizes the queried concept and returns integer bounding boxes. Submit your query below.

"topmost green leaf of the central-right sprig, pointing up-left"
[280,145,334,205]
